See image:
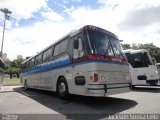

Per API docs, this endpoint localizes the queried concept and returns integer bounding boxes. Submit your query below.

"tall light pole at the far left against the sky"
[0,8,12,57]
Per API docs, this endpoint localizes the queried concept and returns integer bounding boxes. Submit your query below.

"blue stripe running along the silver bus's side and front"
[21,57,128,75]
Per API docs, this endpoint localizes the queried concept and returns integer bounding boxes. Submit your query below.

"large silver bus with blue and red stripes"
[20,25,130,98]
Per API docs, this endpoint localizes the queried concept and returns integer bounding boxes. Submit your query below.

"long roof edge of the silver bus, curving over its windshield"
[22,25,118,64]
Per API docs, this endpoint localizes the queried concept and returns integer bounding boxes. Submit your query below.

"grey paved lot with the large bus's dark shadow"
[0,86,160,120]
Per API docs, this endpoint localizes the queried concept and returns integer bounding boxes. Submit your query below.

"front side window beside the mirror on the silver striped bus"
[73,37,84,59]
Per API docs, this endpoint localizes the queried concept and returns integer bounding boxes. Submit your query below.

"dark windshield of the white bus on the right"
[125,52,153,68]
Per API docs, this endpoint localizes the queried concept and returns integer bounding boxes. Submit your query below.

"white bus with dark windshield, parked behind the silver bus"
[124,49,159,87]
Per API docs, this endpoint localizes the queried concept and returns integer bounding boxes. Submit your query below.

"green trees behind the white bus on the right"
[122,43,160,63]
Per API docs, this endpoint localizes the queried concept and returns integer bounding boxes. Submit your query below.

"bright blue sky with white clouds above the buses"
[0,0,160,60]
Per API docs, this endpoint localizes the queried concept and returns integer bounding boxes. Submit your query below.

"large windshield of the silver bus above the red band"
[89,31,125,58]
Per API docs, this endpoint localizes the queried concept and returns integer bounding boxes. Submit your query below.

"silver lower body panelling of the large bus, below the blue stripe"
[20,62,129,96]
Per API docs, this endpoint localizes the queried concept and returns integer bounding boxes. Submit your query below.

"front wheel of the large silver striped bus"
[57,77,69,99]
